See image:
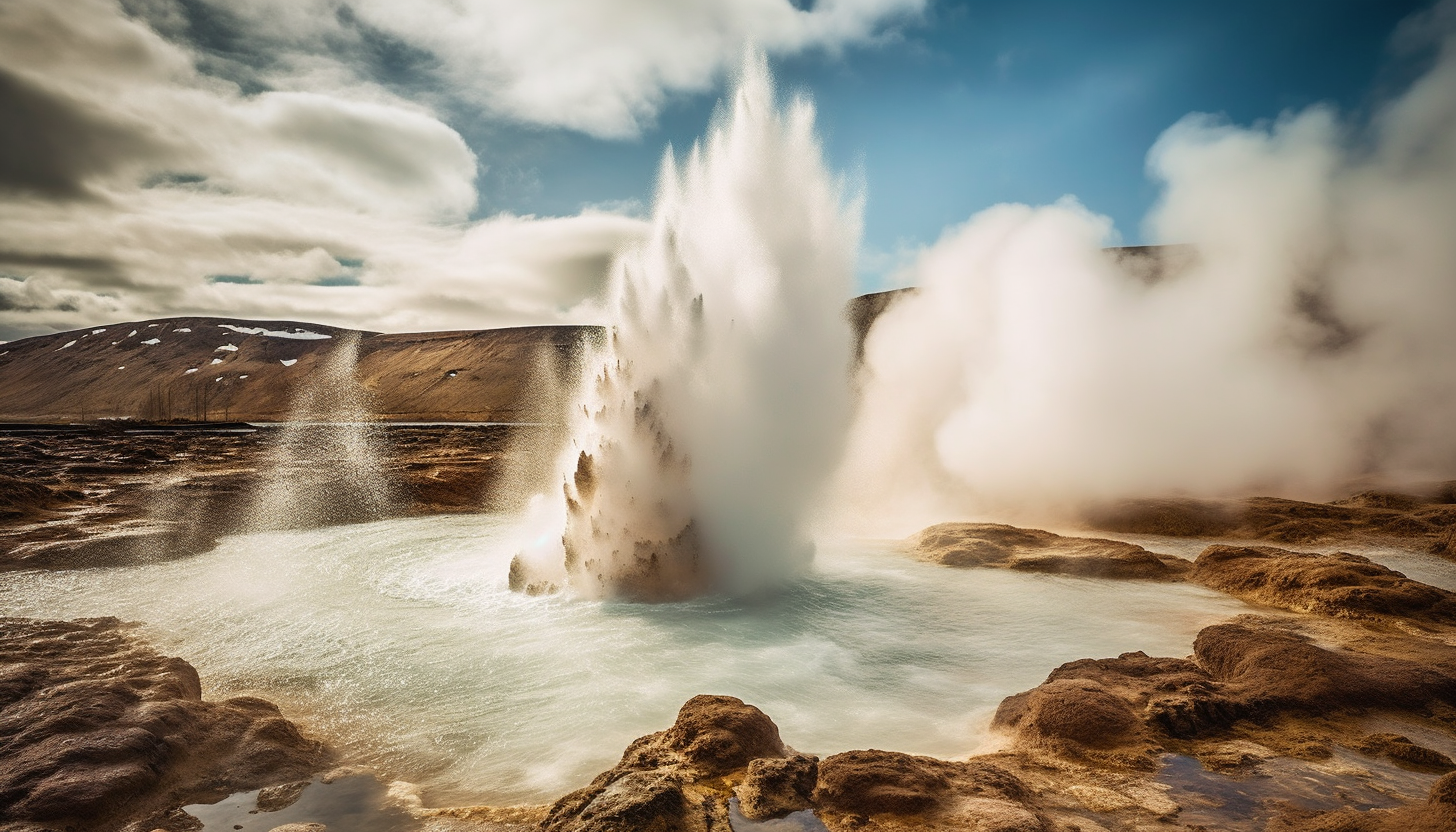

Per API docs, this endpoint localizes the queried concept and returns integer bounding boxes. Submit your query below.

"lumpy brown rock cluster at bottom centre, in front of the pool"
[542,696,1044,832]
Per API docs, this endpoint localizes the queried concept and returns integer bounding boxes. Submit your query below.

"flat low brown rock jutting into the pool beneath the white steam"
[910,523,1188,580]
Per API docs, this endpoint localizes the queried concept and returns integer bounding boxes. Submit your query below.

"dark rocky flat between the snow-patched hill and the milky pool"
[0,423,545,571]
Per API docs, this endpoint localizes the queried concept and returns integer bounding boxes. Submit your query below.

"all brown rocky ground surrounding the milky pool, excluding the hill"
[8,425,1456,832]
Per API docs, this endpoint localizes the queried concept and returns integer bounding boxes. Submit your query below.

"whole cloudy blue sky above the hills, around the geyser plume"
[0,0,1456,340]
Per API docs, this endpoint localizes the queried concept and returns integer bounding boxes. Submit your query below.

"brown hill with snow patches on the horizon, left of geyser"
[0,318,600,421]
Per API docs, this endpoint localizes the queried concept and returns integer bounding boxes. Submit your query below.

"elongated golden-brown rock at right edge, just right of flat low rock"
[1188,545,1456,622]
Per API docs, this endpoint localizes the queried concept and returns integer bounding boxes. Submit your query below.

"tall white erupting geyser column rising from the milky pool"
[511,55,860,600]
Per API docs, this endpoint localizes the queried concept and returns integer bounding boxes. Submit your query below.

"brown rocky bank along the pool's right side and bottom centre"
[419,494,1456,832]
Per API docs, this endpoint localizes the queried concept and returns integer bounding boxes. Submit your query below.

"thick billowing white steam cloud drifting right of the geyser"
[839,27,1456,530]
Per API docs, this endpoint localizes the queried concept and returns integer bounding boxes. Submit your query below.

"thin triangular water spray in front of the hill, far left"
[245,332,395,532]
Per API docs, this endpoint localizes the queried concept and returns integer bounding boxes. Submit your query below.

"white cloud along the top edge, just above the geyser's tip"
[128,0,927,137]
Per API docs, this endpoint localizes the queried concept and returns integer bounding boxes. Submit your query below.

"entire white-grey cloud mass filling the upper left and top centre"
[0,0,925,338]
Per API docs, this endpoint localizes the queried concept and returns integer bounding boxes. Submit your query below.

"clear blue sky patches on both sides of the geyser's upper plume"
[480,0,1428,276]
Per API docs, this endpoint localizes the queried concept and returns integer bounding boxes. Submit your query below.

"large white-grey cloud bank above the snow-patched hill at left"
[0,0,645,338]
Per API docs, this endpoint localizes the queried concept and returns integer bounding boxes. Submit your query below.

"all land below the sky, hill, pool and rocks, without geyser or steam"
[0,294,1456,832]
